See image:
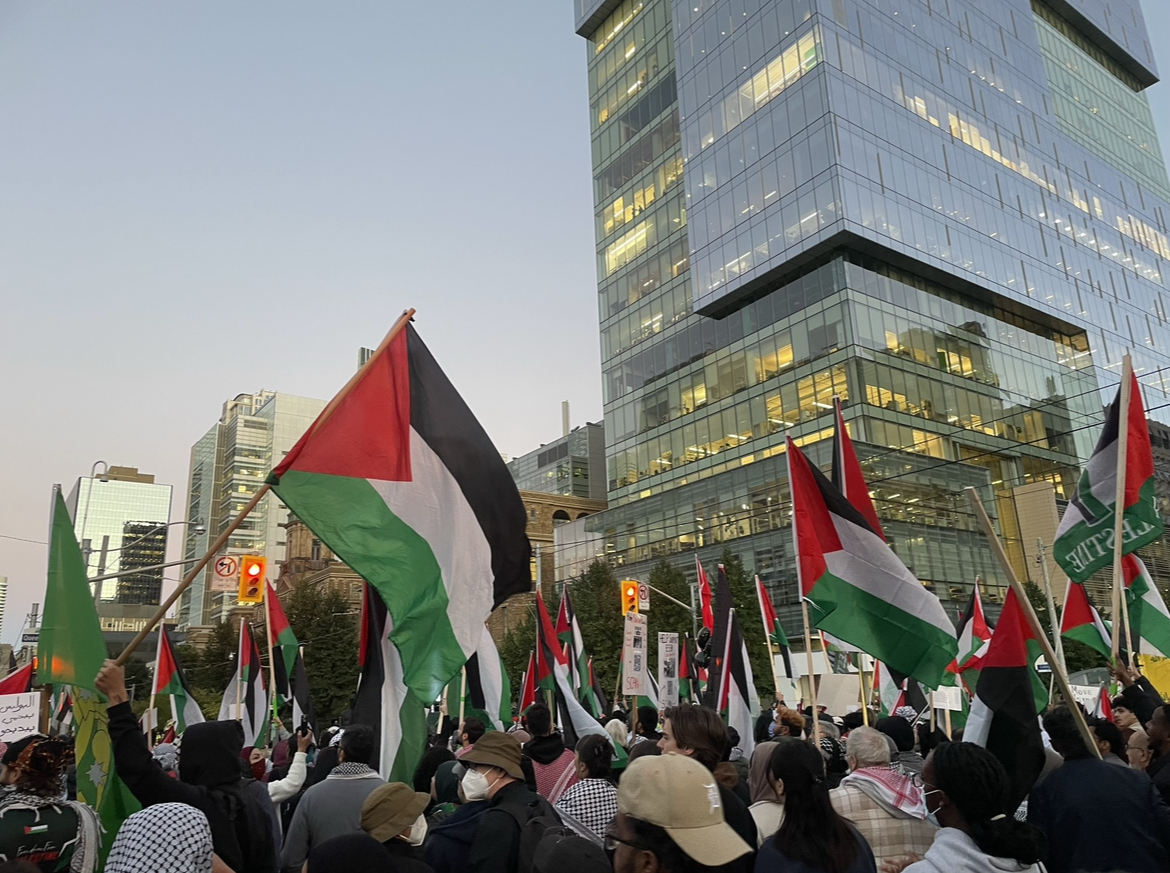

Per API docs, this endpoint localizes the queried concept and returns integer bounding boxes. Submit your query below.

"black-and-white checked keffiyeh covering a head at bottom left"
[105,803,212,873]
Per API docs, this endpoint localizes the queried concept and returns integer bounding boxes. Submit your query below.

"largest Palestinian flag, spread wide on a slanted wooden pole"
[268,324,532,701]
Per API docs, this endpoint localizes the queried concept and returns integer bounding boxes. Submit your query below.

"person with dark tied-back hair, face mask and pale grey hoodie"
[882,743,1048,873]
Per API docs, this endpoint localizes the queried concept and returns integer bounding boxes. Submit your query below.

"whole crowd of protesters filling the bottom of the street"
[0,662,1170,873]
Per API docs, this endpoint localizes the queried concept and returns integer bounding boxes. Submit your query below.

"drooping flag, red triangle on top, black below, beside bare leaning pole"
[963,589,1048,810]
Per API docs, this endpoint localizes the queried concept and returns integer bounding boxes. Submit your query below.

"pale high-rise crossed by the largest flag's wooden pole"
[178,390,325,628]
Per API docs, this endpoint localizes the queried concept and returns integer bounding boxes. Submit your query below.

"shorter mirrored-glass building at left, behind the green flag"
[66,467,172,614]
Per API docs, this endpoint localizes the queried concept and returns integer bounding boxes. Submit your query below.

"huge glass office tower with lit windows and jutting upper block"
[570,0,1170,620]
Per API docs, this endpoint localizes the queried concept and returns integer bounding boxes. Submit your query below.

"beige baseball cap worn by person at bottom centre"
[618,755,751,867]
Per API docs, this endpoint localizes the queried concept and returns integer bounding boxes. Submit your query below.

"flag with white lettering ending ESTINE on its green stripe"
[1052,373,1162,582]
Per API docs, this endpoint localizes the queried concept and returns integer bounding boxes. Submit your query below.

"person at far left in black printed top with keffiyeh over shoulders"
[0,734,98,873]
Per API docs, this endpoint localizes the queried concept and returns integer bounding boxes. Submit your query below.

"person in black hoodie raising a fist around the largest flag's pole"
[95,660,280,873]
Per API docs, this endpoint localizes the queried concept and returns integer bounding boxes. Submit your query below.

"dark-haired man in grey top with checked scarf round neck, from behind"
[281,724,385,869]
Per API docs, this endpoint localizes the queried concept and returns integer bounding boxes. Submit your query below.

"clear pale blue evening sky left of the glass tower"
[0,0,1170,641]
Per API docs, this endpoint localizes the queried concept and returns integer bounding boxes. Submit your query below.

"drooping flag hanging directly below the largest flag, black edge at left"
[351,583,439,784]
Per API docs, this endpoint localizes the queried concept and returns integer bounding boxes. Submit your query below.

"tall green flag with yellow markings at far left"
[36,487,142,865]
